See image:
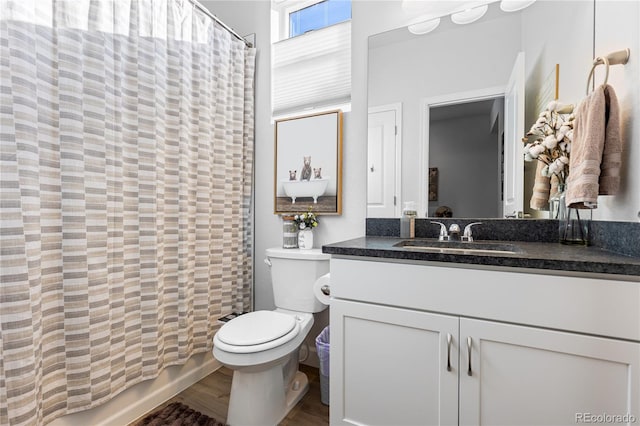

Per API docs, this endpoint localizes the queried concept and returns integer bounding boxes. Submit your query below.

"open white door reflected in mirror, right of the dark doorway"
[502,52,525,217]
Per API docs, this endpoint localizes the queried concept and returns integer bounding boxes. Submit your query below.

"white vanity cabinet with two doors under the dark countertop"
[330,258,640,425]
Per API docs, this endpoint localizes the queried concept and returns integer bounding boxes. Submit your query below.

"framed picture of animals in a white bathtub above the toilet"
[274,110,342,214]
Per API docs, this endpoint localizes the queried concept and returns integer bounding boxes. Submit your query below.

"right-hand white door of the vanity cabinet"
[460,319,640,426]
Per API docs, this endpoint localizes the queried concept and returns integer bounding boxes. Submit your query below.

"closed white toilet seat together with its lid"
[214,311,300,353]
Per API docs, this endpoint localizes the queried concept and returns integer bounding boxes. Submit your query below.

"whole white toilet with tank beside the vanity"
[213,247,331,426]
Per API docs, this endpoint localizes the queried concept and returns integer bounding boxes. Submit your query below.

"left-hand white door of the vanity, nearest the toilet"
[330,299,459,426]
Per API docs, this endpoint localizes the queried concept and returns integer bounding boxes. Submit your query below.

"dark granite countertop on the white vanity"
[322,236,640,282]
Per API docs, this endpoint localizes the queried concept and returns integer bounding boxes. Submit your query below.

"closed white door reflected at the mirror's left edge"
[367,104,401,218]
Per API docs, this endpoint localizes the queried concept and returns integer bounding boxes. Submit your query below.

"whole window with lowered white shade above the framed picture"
[271,0,351,118]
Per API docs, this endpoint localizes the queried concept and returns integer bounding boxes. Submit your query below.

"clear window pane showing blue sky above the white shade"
[289,0,351,37]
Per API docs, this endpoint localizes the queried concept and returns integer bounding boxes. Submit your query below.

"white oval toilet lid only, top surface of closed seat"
[217,311,296,346]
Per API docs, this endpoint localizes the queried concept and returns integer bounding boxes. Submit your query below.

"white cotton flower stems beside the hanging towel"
[522,101,575,183]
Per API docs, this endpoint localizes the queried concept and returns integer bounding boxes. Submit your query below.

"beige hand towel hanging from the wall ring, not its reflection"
[566,85,622,208]
